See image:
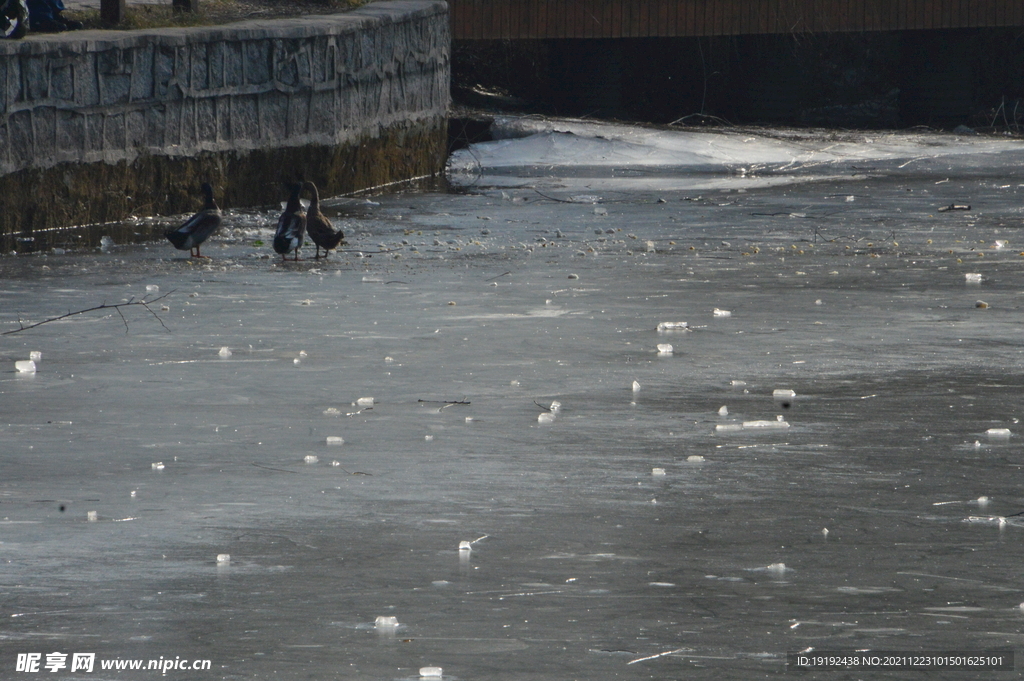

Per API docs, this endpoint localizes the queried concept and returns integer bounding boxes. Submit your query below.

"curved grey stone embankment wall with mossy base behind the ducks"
[0,0,450,233]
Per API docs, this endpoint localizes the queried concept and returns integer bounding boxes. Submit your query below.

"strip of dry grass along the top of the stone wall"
[65,0,369,31]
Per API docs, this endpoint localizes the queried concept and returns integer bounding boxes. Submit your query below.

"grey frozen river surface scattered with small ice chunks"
[0,122,1024,681]
